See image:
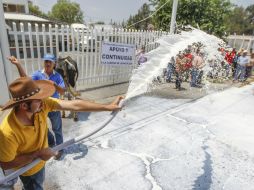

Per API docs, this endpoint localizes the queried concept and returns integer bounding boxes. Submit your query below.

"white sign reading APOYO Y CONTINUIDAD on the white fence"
[101,42,135,65]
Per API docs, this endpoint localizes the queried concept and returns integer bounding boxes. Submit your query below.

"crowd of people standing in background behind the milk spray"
[151,43,254,90]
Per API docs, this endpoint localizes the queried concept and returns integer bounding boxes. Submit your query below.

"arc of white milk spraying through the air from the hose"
[126,28,224,100]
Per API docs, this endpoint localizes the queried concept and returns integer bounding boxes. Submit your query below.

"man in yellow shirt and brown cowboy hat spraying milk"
[0,77,123,190]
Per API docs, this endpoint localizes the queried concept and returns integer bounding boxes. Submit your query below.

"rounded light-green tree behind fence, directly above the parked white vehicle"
[49,0,84,24]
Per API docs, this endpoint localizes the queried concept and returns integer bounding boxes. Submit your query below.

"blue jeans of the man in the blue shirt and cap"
[48,111,63,147]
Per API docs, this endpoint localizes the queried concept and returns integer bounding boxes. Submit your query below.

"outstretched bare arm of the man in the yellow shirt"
[56,96,123,112]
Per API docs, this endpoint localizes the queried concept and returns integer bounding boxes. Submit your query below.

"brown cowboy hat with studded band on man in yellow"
[2,77,56,110]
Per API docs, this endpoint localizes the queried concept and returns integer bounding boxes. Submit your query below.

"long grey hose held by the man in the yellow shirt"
[0,100,124,184]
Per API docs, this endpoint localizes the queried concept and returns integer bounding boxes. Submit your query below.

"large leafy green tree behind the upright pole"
[150,0,232,37]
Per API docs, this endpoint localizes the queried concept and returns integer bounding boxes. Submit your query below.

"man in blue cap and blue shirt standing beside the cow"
[9,54,65,160]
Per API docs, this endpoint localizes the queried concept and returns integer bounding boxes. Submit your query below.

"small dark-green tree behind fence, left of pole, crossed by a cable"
[127,3,152,30]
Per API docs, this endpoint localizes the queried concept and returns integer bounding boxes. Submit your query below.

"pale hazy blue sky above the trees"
[33,0,254,23]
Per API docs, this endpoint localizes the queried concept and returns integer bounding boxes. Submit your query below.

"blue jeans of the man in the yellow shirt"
[19,167,45,190]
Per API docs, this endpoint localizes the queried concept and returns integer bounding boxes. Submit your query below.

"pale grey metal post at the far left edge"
[0,0,12,104]
